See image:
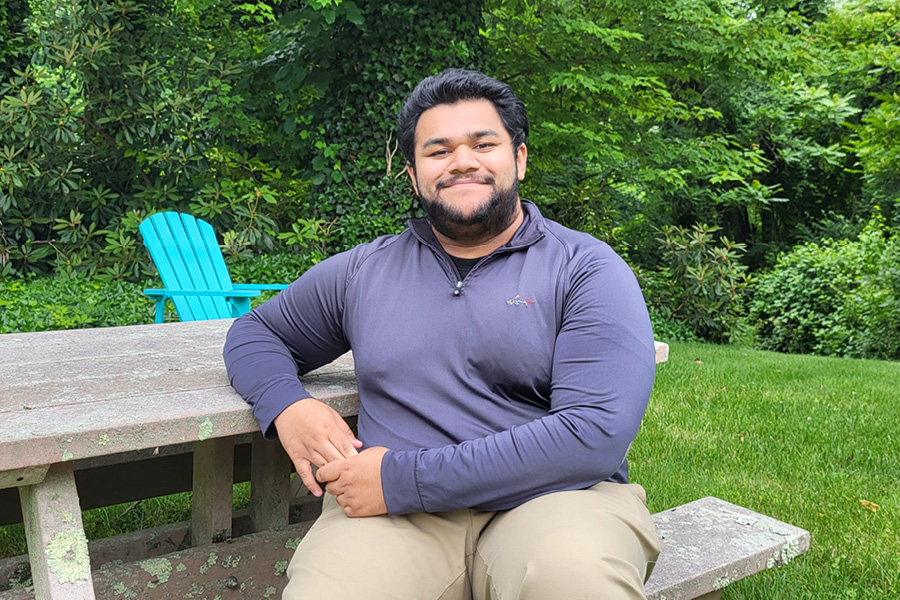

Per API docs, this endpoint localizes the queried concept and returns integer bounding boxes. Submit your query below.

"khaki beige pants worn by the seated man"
[283,482,659,600]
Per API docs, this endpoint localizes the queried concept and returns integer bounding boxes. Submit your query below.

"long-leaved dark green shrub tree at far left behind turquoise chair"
[0,0,302,277]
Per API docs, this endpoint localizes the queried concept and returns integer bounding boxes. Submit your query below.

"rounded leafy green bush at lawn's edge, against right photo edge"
[749,213,900,359]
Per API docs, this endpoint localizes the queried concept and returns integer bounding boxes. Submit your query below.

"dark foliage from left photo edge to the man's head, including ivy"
[0,0,490,279]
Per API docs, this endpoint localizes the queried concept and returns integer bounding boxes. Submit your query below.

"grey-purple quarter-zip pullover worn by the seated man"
[225,202,655,514]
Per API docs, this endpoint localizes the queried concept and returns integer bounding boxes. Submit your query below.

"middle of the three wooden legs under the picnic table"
[191,437,234,546]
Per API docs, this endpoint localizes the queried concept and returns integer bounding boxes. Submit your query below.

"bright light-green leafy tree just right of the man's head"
[488,0,816,265]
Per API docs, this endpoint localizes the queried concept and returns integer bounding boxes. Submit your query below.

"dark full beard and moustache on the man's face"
[418,177,519,243]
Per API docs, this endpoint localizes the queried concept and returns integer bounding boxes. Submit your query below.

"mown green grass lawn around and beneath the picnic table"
[0,343,900,600]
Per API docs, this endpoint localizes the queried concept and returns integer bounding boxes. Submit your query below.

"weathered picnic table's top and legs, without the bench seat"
[0,319,358,600]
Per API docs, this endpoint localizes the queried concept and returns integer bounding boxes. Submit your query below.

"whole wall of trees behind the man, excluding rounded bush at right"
[0,0,900,356]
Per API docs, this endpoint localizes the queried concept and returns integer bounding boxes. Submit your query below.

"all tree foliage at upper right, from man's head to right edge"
[489,0,900,268]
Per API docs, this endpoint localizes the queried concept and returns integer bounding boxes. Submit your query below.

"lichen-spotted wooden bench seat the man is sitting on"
[0,497,809,600]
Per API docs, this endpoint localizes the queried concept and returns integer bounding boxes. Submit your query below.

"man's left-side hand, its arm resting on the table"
[275,398,362,497]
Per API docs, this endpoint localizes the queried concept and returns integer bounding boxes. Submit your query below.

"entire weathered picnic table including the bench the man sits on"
[0,320,809,600]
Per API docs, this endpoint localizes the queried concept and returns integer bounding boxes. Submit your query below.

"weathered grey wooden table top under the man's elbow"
[0,319,359,472]
